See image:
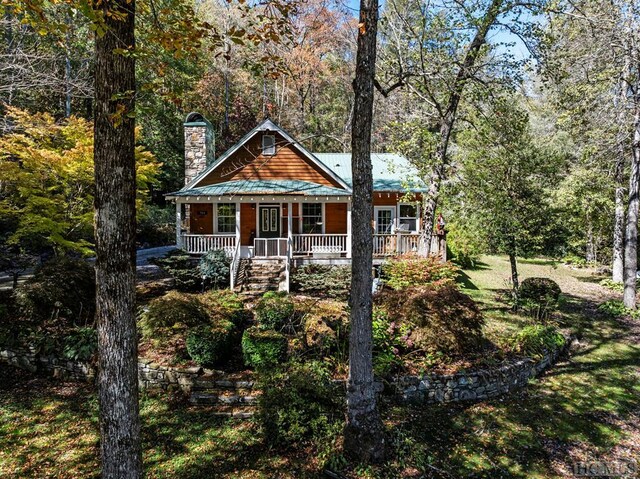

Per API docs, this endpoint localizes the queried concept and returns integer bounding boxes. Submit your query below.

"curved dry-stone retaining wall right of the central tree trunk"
[393,338,572,404]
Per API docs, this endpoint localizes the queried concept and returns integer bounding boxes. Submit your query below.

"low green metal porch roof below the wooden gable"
[167,180,351,197]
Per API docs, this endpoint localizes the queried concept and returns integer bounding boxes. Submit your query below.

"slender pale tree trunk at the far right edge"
[623,103,640,309]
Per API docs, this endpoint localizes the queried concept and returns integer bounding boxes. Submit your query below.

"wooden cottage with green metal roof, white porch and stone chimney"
[167,113,446,290]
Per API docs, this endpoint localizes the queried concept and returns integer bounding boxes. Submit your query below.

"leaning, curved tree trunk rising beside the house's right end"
[423,0,504,248]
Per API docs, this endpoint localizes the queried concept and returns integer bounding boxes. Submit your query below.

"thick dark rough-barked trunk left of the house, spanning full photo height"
[94,0,142,479]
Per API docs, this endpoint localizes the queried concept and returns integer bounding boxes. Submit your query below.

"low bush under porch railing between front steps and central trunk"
[291,264,351,299]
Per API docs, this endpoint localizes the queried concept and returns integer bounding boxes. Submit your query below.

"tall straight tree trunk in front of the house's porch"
[344,0,385,463]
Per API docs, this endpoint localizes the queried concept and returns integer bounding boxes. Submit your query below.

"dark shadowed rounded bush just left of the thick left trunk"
[15,256,96,322]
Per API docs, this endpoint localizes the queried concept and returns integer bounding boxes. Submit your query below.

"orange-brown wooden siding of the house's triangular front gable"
[198,133,341,188]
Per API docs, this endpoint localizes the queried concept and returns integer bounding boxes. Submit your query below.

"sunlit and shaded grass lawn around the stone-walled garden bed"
[0,257,640,479]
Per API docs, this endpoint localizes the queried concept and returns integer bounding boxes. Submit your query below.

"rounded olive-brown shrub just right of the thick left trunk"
[139,291,210,342]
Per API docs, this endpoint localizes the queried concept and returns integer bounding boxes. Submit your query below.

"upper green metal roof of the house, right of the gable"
[314,153,426,192]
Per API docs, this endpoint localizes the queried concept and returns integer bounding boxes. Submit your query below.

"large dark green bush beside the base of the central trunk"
[256,361,343,447]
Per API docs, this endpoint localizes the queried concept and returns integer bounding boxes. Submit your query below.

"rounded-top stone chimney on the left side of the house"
[184,112,215,185]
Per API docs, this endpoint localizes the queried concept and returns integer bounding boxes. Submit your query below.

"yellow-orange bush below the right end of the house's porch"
[382,257,458,289]
